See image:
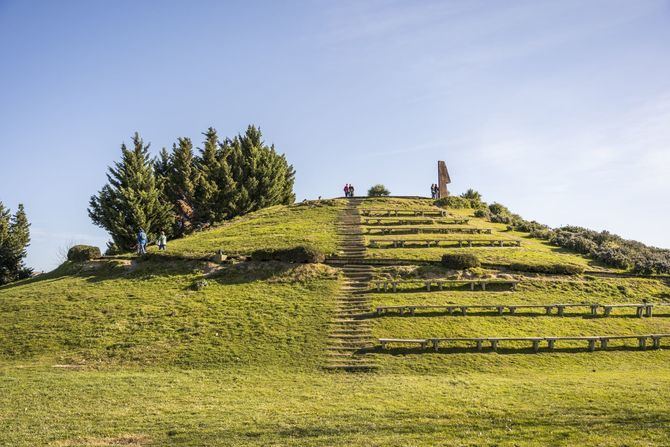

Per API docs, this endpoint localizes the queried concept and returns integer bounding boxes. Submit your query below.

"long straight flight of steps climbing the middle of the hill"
[326,198,376,371]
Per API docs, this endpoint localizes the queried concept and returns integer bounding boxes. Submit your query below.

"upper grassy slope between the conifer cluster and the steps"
[160,200,344,258]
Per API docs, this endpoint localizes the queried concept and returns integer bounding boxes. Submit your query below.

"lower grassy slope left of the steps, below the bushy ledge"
[0,261,337,367]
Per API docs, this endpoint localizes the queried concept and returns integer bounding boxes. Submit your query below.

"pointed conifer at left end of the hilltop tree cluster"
[88,132,174,250]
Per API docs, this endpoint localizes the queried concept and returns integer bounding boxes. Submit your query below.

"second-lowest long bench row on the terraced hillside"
[375,303,654,318]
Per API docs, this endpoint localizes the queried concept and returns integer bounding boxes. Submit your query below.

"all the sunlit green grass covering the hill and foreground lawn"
[0,199,670,446]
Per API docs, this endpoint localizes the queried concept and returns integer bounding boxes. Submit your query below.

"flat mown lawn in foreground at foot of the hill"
[0,364,670,447]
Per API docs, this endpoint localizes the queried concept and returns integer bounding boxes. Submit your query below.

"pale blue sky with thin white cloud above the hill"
[0,0,670,270]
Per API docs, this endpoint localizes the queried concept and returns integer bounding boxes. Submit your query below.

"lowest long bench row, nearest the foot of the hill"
[379,334,670,353]
